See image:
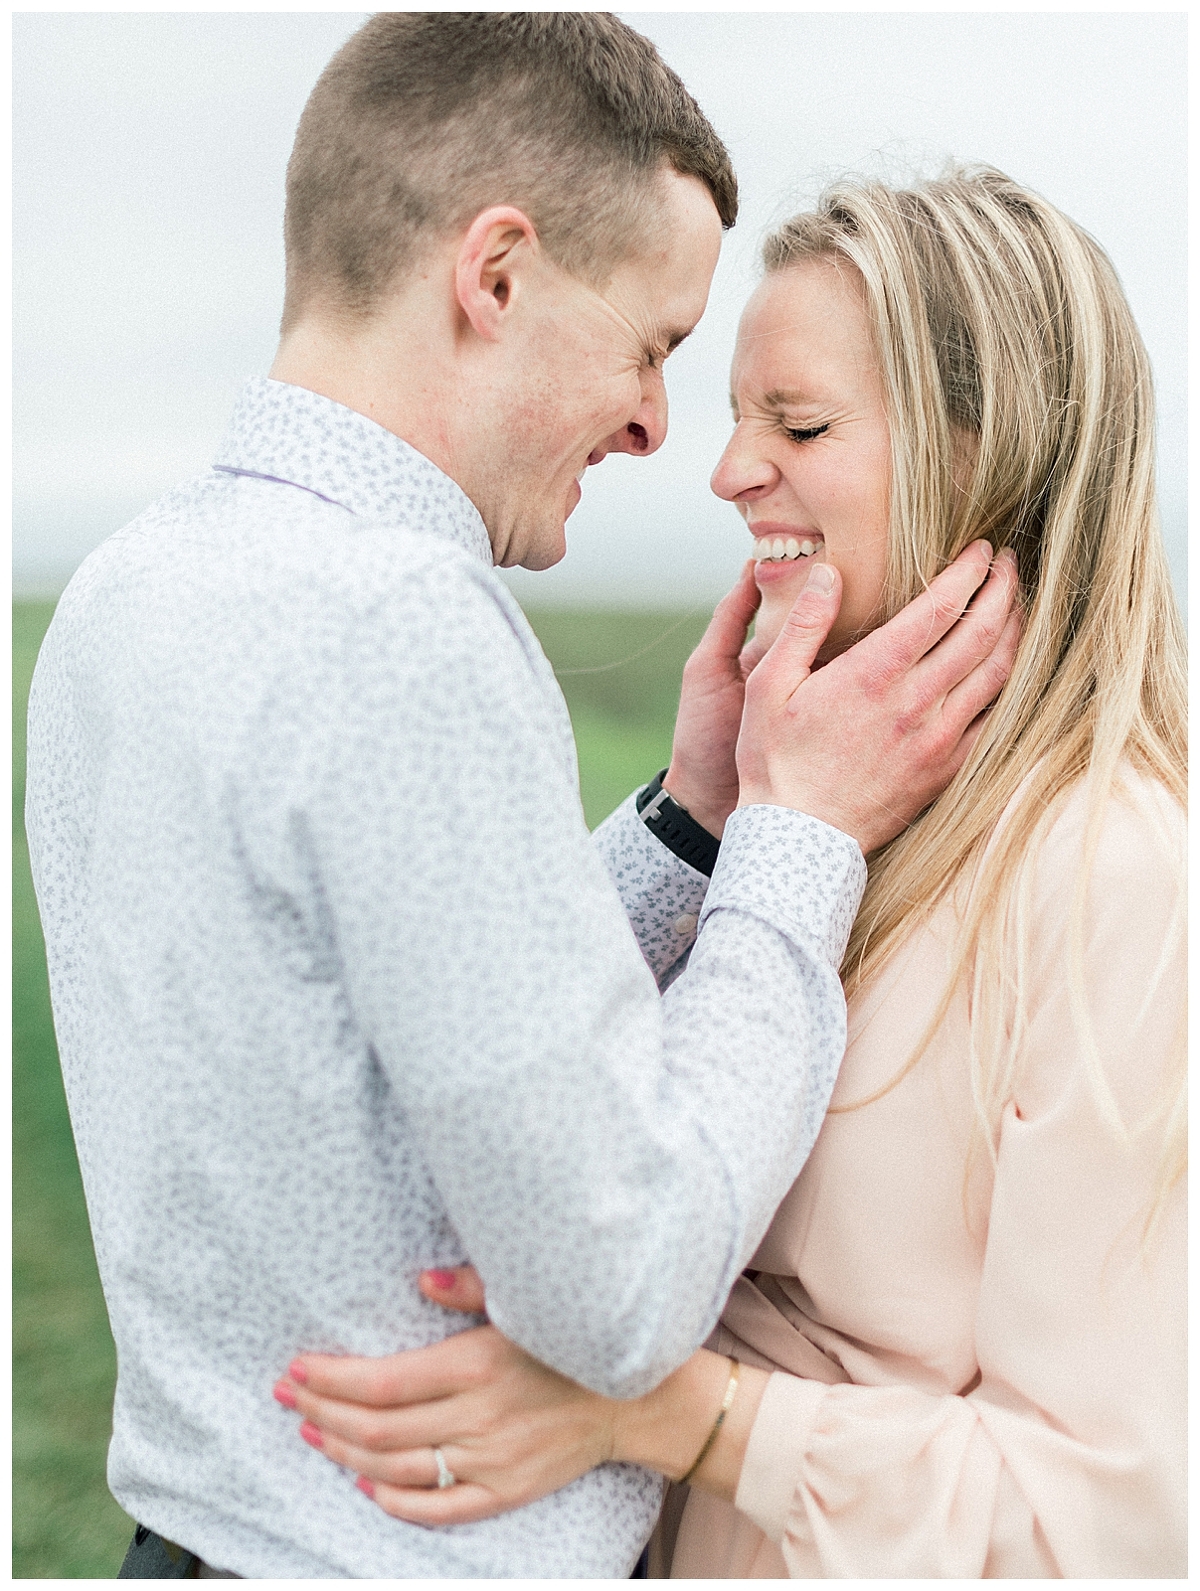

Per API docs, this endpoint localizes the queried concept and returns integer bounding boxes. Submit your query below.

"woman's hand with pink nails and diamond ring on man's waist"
[267,1266,616,1524]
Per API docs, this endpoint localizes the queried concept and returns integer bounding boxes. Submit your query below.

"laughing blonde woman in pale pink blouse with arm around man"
[268,169,1186,1577]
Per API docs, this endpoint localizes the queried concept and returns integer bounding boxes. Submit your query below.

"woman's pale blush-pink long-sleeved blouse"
[668,776,1187,1578]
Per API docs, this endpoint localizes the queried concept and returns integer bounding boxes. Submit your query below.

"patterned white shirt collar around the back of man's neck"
[215,375,493,568]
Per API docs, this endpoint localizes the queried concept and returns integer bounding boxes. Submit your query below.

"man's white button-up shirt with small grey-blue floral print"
[29,380,864,1578]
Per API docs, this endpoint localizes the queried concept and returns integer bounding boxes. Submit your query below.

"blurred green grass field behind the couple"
[13,603,707,1578]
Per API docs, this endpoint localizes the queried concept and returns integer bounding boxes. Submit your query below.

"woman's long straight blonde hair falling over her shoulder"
[764,167,1186,1211]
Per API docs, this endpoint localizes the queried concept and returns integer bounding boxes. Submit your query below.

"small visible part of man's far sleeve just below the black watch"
[592,786,708,983]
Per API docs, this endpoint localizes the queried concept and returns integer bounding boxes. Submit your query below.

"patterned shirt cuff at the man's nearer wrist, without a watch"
[700,807,867,967]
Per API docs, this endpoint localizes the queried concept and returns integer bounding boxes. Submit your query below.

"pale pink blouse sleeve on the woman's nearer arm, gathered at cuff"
[737,773,1187,1578]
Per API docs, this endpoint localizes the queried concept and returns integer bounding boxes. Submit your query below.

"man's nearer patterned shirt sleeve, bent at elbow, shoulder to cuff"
[276,557,864,1397]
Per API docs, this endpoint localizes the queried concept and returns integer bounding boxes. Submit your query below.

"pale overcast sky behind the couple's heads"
[13,11,1186,605]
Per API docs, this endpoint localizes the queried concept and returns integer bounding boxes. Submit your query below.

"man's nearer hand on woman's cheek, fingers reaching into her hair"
[737,541,1020,854]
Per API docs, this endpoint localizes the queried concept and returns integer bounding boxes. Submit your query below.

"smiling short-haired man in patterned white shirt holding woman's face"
[29,13,1007,1577]
